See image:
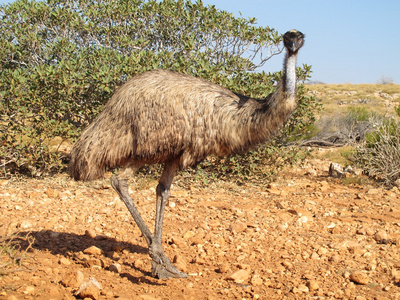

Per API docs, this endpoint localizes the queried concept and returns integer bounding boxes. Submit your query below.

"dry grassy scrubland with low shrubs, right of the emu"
[310,83,400,185]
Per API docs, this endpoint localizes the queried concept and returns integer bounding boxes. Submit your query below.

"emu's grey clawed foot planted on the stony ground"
[150,245,188,279]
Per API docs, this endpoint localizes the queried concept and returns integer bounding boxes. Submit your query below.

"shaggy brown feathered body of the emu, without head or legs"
[70,70,295,180]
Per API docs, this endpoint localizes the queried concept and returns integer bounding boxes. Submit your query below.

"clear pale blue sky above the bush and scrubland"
[0,0,400,84]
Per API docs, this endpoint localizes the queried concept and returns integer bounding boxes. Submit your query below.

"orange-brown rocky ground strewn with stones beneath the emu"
[0,161,400,300]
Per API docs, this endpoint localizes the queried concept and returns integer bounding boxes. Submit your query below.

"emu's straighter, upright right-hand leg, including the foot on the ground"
[149,161,187,279]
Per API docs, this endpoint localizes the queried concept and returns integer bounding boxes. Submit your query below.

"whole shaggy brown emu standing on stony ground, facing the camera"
[69,30,304,278]
